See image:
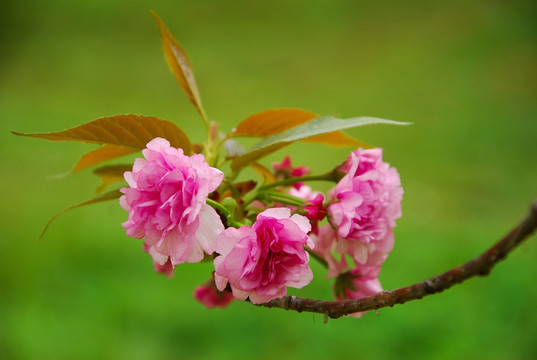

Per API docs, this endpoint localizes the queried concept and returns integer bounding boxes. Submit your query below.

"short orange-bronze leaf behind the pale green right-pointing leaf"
[233,108,318,137]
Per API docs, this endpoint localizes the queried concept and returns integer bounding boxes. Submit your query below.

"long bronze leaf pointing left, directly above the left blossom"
[12,114,191,154]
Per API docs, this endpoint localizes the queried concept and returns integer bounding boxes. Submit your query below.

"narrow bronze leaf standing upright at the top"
[151,11,207,120]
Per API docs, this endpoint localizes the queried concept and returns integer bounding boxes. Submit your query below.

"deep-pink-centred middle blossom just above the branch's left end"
[214,208,314,304]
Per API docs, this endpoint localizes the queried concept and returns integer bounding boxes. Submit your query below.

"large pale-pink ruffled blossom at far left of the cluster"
[120,138,224,266]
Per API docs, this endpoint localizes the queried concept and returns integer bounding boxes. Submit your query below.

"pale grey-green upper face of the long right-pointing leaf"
[249,116,408,151]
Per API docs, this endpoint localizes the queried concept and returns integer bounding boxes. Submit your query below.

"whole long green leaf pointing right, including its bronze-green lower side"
[231,116,408,171]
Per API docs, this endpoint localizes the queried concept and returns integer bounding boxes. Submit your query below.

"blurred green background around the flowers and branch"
[0,0,537,359]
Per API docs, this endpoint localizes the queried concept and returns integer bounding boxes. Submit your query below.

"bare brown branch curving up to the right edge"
[261,201,537,319]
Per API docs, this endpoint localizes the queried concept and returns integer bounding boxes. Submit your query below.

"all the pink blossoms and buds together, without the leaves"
[120,138,403,316]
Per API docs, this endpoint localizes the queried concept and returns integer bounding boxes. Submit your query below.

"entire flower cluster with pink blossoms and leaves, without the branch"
[18,12,405,318]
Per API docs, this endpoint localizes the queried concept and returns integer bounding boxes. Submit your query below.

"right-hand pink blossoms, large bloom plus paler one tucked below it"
[314,149,403,282]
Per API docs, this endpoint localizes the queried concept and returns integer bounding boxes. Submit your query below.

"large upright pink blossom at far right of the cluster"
[328,149,403,264]
